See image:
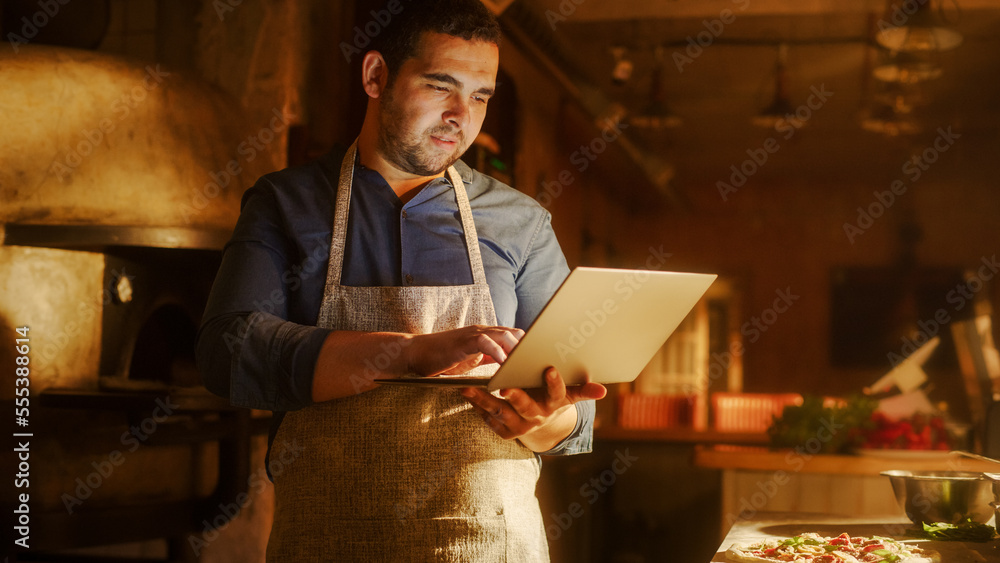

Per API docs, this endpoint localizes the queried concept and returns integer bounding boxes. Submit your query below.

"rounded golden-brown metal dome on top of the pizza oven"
[0,46,287,243]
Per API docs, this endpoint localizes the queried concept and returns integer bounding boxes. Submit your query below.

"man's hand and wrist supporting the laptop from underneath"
[462,367,607,452]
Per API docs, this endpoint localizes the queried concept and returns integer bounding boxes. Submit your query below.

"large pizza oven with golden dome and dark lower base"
[0,46,287,560]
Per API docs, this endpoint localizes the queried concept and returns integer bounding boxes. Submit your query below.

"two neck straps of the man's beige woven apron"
[327,140,486,285]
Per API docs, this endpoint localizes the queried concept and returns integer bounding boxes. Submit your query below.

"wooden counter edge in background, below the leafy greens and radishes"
[694,446,1000,475]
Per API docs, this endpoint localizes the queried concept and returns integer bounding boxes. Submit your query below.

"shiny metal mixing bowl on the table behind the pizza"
[882,470,993,524]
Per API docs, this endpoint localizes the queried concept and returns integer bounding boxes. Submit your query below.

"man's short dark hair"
[371,0,500,81]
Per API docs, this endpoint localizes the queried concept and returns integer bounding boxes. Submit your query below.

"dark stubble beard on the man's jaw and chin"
[376,88,466,176]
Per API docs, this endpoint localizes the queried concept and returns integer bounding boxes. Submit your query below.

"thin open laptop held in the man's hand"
[375,267,716,391]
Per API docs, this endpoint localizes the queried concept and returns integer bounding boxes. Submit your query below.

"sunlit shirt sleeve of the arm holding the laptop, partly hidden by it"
[515,211,597,455]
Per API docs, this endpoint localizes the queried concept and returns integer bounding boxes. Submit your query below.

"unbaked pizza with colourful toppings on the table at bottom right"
[726,533,941,563]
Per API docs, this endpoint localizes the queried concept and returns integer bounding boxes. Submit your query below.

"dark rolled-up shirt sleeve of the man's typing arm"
[196,179,330,411]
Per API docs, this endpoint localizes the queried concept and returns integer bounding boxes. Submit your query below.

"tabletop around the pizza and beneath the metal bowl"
[712,513,1000,563]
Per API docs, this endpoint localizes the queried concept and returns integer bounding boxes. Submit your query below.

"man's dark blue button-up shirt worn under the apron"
[197,151,595,455]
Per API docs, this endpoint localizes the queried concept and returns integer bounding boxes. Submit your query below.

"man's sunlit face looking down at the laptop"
[377,32,499,176]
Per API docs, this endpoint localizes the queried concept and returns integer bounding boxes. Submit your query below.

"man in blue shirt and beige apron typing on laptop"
[198,0,605,562]
